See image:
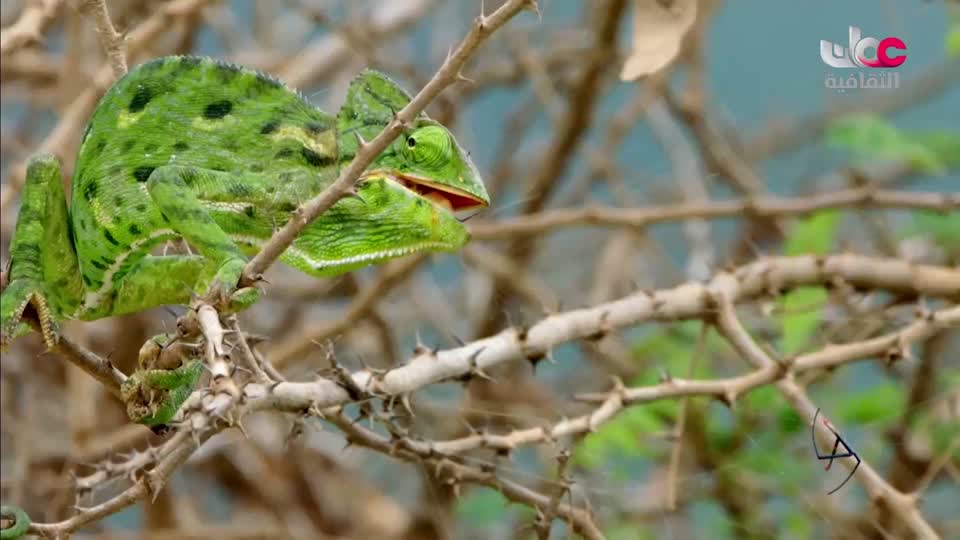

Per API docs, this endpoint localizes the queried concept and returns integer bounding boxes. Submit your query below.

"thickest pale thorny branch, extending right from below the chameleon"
[245,255,960,412]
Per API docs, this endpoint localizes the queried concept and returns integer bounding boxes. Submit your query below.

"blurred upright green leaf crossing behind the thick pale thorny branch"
[781,210,841,355]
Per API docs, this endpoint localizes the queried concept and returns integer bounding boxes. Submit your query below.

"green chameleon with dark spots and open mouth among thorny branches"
[0,57,488,347]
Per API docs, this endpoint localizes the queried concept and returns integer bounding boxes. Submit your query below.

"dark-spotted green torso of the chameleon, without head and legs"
[70,56,338,318]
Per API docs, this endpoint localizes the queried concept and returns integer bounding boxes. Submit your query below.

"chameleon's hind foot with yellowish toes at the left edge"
[0,278,59,349]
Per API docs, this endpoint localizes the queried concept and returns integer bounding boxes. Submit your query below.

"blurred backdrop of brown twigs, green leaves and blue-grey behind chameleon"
[0,0,960,539]
